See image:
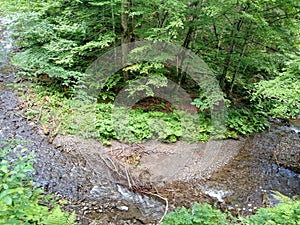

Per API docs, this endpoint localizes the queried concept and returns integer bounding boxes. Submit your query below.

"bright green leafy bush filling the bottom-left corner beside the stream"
[0,141,76,225]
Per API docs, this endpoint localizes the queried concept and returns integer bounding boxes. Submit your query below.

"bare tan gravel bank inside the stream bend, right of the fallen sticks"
[102,140,244,185]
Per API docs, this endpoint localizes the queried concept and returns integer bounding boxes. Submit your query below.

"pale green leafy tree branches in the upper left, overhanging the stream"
[5,0,114,87]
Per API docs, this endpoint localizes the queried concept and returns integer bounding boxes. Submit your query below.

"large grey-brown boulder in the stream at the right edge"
[274,132,300,173]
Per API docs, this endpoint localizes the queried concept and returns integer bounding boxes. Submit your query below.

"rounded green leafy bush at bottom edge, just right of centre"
[162,203,229,225]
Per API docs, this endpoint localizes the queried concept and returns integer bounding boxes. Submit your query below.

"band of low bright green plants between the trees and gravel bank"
[12,84,268,144]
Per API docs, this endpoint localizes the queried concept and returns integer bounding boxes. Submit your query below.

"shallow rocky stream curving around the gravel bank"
[0,16,300,224]
